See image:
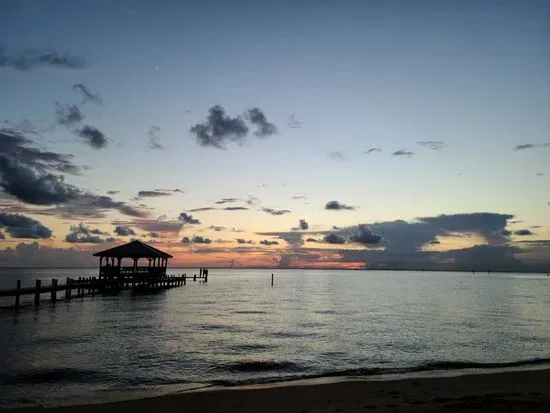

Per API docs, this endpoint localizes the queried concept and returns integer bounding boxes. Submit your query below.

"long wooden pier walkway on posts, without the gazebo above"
[0,274,208,309]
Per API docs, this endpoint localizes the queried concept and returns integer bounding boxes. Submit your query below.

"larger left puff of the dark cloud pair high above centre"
[189,105,248,149]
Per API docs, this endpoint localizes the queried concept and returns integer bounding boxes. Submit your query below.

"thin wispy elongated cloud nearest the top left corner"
[0,45,88,72]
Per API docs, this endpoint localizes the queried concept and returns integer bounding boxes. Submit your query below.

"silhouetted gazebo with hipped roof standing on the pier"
[94,241,173,279]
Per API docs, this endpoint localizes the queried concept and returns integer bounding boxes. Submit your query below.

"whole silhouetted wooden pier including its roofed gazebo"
[0,241,208,309]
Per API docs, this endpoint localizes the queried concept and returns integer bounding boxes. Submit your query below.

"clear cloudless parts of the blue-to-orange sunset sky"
[0,0,550,265]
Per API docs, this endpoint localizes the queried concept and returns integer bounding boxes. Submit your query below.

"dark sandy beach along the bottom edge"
[5,369,550,413]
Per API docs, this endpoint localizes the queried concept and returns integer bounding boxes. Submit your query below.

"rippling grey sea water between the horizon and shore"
[0,269,550,408]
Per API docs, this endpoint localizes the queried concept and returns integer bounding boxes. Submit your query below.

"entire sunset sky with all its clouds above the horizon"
[0,0,550,271]
